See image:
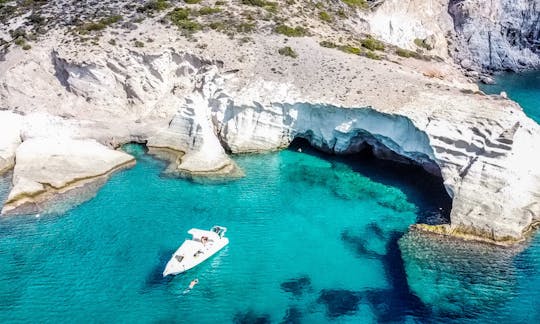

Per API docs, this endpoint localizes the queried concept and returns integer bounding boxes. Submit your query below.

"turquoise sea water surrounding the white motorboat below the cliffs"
[0,74,540,323]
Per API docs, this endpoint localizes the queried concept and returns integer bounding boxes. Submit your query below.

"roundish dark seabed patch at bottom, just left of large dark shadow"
[317,289,360,319]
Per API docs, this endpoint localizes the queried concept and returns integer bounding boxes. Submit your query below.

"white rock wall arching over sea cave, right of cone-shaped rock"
[210,86,540,242]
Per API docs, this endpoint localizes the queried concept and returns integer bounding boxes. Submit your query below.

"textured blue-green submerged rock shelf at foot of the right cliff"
[399,231,519,318]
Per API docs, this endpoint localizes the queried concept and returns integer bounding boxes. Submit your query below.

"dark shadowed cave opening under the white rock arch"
[288,137,452,225]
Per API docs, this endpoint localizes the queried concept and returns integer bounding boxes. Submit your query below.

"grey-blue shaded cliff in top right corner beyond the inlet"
[449,0,540,71]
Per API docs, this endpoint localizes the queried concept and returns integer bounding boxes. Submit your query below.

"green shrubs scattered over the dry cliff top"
[0,0,430,66]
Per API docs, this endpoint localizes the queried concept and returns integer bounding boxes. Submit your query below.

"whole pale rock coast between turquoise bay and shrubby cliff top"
[0,1,540,244]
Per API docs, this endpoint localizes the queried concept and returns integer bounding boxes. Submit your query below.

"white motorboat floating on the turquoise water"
[163,226,229,277]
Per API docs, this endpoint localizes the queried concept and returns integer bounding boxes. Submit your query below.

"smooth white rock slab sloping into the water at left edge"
[2,138,134,214]
